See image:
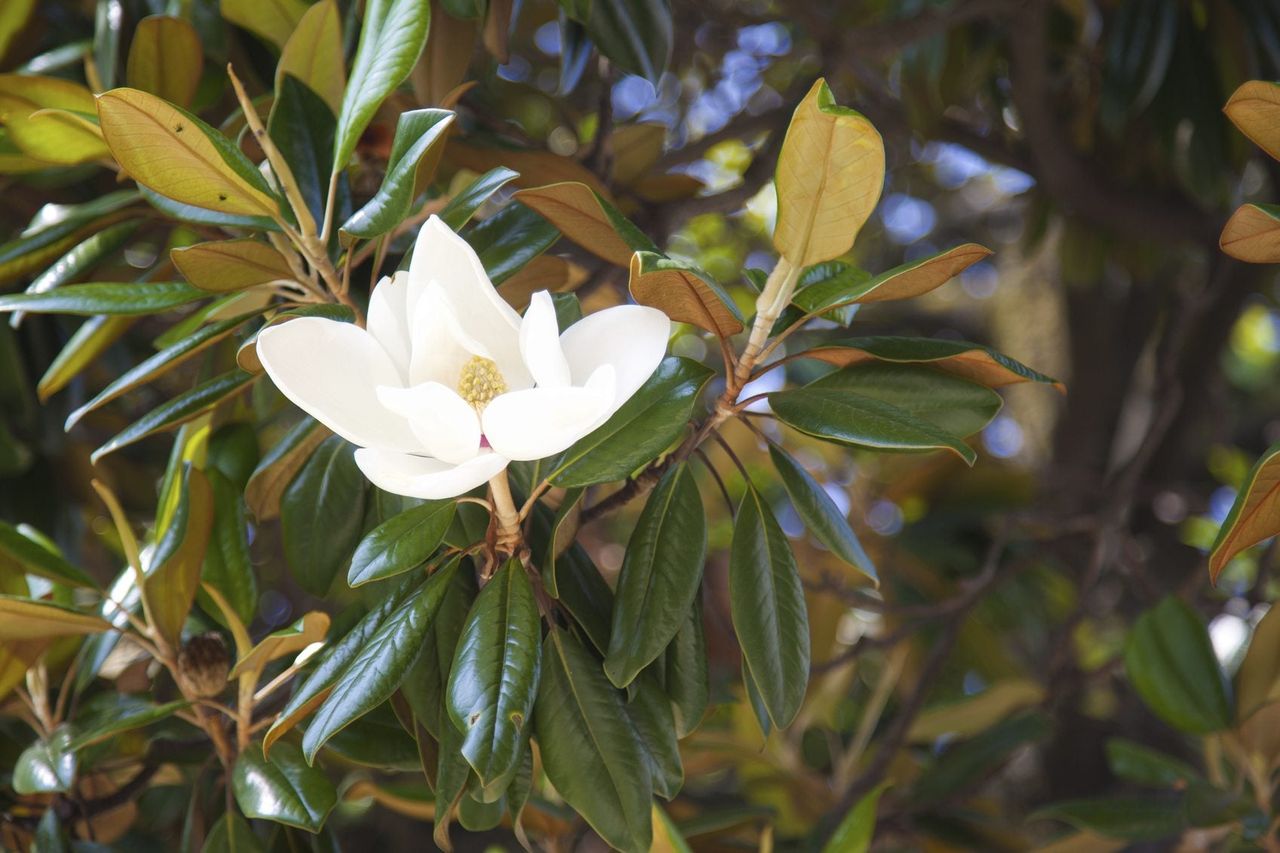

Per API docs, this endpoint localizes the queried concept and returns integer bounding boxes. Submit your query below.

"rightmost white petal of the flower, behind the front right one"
[561,305,671,415]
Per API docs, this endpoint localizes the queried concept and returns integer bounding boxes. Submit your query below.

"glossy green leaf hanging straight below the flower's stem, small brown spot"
[448,560,541,784]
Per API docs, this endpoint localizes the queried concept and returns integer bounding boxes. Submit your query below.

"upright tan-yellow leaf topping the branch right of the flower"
[773,78,884,268]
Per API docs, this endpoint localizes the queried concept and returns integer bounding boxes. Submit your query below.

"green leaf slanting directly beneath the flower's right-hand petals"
[550,356,712,487]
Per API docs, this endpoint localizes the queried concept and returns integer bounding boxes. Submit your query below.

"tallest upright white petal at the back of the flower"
[408,216,525,378]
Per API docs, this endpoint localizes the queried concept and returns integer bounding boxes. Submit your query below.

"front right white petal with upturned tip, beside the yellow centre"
[480,365,616,461]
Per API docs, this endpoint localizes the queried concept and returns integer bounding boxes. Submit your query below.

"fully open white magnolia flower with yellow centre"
[250,216,671,498]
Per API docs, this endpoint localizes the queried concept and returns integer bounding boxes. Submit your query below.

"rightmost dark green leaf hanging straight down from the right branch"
[728,487,809,729]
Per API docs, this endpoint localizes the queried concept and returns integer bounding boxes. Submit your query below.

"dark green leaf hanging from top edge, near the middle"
[582,0,672,86]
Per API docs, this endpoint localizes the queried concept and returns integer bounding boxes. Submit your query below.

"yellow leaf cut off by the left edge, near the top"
[0,74,109,165]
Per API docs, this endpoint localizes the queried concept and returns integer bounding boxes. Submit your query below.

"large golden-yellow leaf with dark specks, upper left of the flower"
[97,88,279,216]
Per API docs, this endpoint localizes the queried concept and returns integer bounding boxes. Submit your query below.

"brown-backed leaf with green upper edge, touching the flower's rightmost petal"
[628,252,742,338]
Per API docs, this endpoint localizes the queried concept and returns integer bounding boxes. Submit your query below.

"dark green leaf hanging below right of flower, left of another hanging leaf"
[604,462,707,688]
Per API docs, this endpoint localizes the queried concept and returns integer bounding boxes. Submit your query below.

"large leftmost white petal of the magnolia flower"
[257,316,421,451]
